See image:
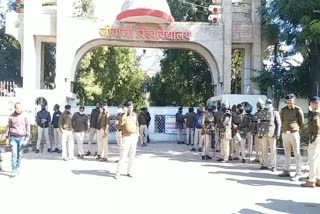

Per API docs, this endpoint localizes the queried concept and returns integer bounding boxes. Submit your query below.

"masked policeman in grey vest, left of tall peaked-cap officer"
[259,99,281,172]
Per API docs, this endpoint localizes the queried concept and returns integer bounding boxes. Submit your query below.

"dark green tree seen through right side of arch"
[149,49,213,106]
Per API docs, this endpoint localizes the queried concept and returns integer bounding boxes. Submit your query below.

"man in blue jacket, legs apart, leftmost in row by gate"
[36,105,52,153]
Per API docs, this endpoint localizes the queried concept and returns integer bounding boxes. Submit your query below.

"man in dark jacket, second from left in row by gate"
[51,104,62,153]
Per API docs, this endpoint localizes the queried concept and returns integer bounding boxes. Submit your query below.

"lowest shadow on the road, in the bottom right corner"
[238,199,320,214]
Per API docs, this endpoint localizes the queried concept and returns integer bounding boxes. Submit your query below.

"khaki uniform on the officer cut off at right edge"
[308,111,320,183]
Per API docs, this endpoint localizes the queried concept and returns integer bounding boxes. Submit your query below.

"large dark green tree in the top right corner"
[261,0,320,96]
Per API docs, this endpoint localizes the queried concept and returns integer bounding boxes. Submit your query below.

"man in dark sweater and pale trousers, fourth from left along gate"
[72,106,88,159]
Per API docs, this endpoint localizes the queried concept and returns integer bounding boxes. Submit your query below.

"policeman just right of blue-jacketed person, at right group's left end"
[202,106,214,160]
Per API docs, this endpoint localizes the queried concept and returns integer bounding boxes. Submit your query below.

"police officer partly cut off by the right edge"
[301,96,320,187]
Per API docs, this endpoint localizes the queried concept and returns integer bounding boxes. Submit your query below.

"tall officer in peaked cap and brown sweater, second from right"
[279,94,304,181]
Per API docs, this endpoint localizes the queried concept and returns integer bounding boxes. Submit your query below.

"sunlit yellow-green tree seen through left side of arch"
[75,47,147,107]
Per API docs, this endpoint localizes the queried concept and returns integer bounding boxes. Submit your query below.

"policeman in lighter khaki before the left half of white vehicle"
[217,105,232,163]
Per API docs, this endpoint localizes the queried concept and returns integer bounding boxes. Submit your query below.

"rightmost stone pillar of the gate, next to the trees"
[251,0,263,94]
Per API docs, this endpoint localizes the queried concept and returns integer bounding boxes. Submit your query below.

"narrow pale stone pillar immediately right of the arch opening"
[222,1,232,94]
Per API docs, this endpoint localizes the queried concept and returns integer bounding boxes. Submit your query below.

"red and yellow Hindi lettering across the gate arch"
[99,24,191,41]
